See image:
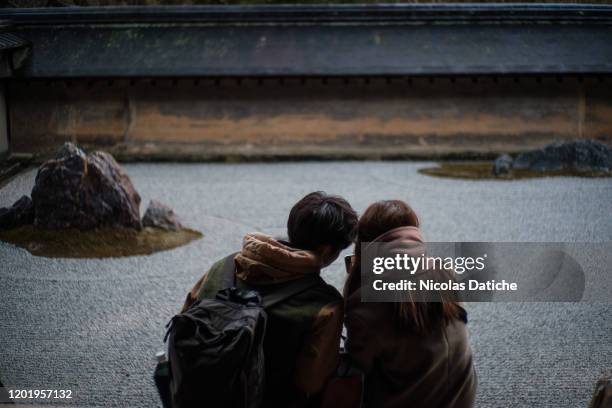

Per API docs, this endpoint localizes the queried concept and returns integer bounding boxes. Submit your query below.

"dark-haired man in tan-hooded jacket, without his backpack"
[183,192,357,407]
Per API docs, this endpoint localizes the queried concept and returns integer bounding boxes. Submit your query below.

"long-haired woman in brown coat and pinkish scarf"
[344,200,476,408]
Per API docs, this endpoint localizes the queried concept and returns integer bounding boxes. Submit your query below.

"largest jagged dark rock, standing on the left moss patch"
[32,143,140,229]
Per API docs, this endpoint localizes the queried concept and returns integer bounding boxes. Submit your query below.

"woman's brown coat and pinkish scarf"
[345,227,476,408]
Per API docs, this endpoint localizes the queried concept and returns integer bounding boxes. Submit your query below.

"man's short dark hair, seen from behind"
[287,191,358,250]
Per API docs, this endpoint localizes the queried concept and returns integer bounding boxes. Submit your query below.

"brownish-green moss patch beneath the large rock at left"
[0,225,203,258]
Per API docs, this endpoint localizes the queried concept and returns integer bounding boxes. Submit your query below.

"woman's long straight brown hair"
[344,200,460,333]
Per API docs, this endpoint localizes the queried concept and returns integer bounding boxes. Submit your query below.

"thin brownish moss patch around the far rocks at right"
[419,162,612,180]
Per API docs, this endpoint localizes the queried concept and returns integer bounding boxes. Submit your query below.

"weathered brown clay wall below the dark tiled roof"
[9,77,612,159]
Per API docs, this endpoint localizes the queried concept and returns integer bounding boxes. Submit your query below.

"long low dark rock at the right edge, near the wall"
[512,140,612,172]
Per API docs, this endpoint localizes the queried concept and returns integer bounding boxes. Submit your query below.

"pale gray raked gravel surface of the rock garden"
[0,162,612,408]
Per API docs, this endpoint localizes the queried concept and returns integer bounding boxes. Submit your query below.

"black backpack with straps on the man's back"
[160,255,321,408]
